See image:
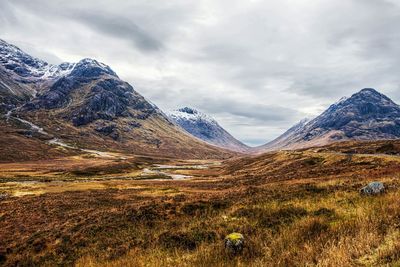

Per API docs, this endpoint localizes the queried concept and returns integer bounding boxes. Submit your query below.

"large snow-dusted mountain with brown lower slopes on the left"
[0,41,232,160]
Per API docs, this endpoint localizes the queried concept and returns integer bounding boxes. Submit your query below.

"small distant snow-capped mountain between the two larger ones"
[168,107,249,152]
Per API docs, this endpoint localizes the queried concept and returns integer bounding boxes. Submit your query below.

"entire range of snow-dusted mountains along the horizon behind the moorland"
[0,40,400,160]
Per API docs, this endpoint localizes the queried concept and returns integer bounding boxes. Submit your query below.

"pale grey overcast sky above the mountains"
[0,0,400,146]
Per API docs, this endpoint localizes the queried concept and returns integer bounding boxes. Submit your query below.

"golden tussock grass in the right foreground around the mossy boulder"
[70,188,400,266]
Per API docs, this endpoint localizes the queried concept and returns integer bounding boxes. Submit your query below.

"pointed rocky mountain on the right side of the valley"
[255,88,400,152]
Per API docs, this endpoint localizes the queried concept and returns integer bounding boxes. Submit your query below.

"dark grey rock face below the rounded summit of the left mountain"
[24,73,157,126]
